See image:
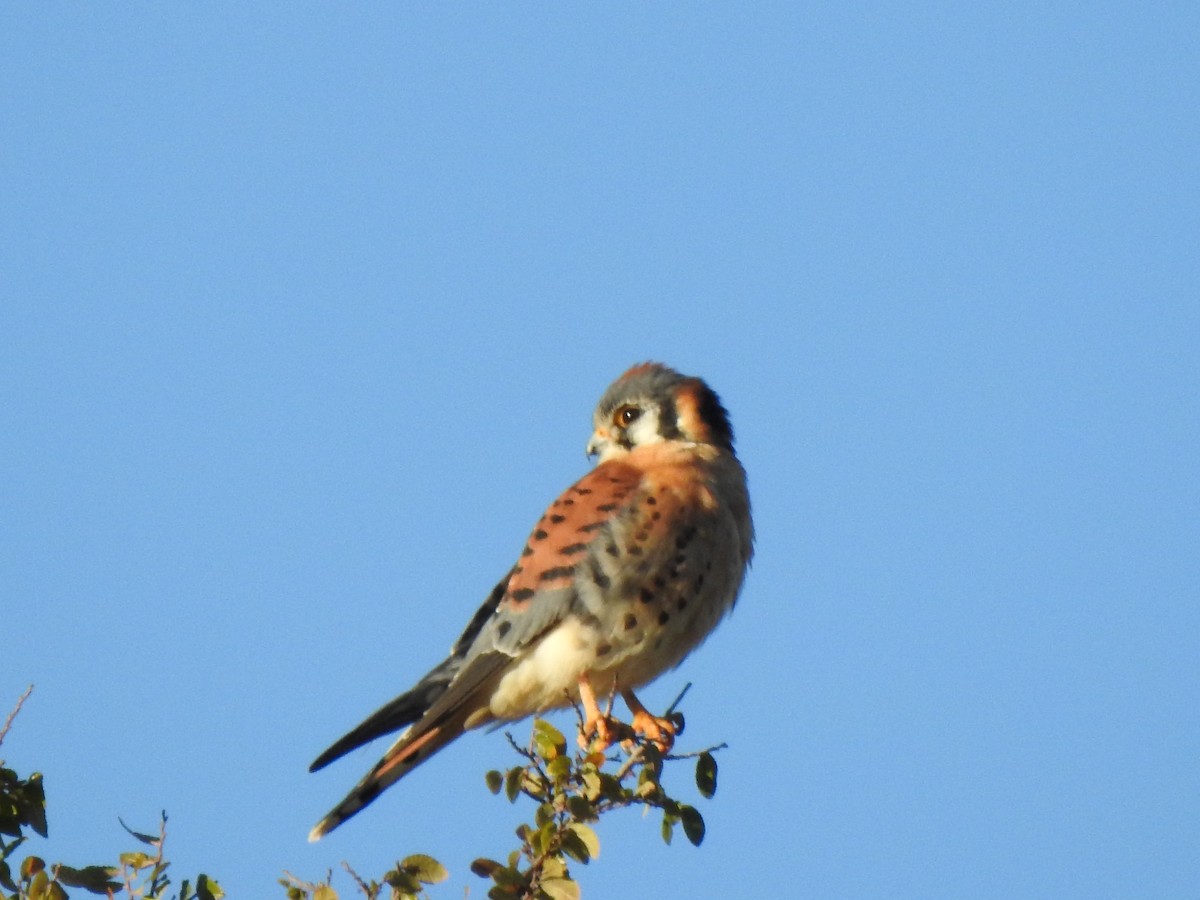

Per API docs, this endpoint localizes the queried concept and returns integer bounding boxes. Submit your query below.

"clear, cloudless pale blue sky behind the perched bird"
[0,2,1200,898]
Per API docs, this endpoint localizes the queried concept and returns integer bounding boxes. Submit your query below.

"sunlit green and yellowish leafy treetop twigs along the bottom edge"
[0,689,724,900]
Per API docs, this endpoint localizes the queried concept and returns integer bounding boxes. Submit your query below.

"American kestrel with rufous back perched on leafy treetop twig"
[308,362,754,840]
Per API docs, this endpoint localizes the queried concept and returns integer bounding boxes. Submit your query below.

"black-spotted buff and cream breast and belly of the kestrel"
[482,451,746,716]
